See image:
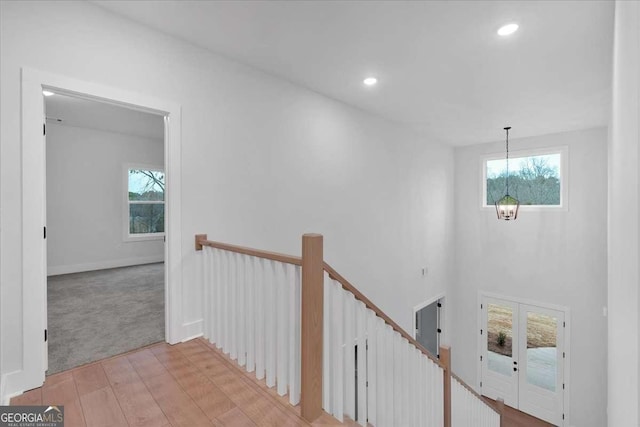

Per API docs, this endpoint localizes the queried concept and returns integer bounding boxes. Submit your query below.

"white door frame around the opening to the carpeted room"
[15,67,184,393]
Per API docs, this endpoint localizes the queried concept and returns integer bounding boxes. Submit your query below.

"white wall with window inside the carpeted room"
[47,122,164,275]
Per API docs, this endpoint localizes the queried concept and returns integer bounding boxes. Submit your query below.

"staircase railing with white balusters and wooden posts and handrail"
[195,234,502,427]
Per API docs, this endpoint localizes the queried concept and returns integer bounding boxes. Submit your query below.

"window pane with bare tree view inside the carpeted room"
[127,168,164,236]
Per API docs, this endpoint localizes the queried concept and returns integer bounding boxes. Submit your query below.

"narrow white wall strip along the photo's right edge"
[608,1,640,426]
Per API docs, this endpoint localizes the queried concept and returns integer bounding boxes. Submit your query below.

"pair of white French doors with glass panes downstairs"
[480,297,566,426]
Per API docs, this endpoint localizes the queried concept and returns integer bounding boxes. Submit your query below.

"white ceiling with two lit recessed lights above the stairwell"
[95,0,614,145]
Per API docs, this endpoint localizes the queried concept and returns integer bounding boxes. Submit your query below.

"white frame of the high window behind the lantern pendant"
[480,145,569,212]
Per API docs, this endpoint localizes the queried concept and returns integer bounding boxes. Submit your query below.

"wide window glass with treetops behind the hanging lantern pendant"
[485,151,563,207]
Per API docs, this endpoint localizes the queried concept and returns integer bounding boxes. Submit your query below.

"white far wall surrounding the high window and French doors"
[452,128,608,427]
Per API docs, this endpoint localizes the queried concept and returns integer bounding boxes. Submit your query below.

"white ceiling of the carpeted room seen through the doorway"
[44,94,164,141]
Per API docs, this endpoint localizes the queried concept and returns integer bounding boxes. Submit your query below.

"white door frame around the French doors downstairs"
[476,290,571,425]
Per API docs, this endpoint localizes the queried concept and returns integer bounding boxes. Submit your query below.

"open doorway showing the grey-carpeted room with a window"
[43,90,166,375]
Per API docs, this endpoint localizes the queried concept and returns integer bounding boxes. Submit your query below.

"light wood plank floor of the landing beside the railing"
[11,339,355,427]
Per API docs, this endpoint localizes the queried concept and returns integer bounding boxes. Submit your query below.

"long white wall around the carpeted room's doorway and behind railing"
[0,2,453,388]
